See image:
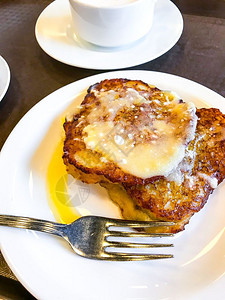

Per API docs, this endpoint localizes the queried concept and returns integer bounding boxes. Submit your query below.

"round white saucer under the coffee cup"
[35,0,183,70]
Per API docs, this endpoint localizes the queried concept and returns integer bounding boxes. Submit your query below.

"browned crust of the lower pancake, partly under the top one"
[124,108,225,232]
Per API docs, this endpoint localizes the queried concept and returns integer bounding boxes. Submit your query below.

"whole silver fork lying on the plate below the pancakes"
[0,215,174,261]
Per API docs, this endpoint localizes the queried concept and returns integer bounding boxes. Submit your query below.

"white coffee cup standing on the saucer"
[69,0,157,47]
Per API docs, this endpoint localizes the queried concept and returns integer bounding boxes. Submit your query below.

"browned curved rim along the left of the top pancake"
[63,79,160,184]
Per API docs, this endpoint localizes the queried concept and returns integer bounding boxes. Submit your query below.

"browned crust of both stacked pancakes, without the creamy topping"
[63,79,225,233]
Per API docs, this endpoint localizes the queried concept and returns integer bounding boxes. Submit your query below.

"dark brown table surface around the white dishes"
[0,0,225,299]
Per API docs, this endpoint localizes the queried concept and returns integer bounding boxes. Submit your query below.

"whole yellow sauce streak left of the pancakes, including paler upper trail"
[45,90,89,223]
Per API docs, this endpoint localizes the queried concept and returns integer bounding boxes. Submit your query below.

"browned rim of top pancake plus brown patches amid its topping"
[63,79,197,185]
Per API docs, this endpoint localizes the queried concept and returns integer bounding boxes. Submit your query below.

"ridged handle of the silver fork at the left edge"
[0,215,66,237]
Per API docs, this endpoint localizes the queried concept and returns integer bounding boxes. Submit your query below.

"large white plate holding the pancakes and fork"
[0,71,225,300]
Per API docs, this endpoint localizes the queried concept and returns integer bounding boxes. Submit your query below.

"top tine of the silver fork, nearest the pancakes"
[107,219,175,228]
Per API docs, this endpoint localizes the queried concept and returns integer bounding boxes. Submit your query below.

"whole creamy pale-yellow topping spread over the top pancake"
[83,88,197,179]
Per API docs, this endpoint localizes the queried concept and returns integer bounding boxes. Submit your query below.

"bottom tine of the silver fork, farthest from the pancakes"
[102,252,173,261]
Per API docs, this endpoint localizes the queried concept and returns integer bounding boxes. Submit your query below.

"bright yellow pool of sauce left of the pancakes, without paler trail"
[47,141,80,223]
